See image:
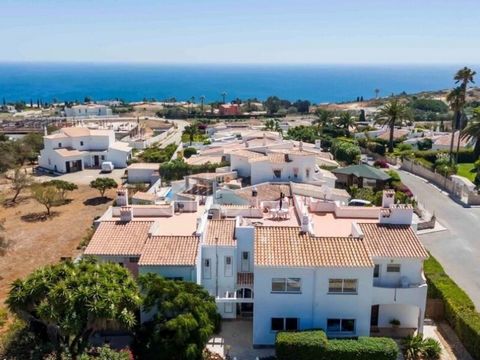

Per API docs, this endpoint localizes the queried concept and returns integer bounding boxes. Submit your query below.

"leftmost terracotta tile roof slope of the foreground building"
[85,220,153,256]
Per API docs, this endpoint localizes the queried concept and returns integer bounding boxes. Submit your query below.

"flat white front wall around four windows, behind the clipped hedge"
[253,266,373,345]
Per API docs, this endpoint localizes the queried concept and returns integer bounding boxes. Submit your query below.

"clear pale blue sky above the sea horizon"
[0,0,480,64]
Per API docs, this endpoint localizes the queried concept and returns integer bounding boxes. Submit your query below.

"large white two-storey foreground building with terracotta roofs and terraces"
[85,167,428,346]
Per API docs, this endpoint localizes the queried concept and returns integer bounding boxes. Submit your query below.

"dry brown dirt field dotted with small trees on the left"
[0,185,114,307]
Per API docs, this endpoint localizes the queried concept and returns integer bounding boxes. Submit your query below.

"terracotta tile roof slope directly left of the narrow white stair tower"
[138,236,199,266]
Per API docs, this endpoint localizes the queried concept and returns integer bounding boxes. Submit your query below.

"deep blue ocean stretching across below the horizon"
[0,63,472,103]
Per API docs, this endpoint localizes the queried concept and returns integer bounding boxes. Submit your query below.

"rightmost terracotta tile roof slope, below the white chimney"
[358,223,428,259]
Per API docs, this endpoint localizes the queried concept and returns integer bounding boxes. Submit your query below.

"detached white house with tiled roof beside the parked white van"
[38,127,132,173]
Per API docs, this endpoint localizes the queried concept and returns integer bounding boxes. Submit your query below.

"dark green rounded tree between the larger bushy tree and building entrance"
[133,274,219,360]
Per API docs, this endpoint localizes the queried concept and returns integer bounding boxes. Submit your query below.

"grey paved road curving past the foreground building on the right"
[399,171,480,309]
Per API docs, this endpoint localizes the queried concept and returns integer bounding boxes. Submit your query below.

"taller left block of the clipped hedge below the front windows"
[275,330,328,360]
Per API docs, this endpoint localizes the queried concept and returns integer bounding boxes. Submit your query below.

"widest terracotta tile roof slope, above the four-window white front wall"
[255,226,373,267]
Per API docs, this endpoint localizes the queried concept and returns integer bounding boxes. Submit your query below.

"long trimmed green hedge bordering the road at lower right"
[424,256,480,359]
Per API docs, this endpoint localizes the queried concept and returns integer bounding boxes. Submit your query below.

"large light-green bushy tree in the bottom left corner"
[7,260,140,358]
